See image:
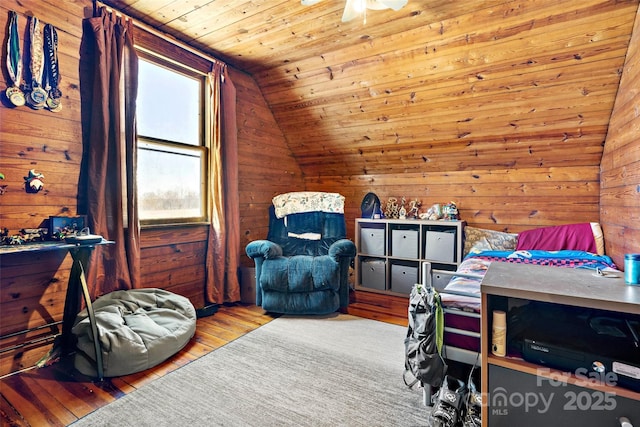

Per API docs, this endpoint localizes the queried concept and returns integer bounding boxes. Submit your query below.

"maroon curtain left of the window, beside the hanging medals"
[78,8,140,298]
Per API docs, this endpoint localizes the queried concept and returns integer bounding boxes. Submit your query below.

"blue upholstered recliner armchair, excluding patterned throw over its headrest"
[246,196,356,314]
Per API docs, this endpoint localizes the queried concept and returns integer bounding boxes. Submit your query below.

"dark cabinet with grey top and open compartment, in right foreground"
[481,262,640,427]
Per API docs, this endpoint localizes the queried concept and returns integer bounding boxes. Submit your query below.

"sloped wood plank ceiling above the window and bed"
[105,0,638,177]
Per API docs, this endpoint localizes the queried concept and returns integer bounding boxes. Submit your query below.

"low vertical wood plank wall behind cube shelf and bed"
[306,166,600,241]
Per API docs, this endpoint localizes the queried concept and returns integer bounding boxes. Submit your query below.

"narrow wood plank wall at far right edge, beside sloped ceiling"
[600,8,640,266]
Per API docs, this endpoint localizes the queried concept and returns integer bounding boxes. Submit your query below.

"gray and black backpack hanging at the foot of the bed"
[402,284,447,387]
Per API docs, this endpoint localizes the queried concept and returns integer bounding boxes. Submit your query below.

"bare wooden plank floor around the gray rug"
[0,302,407,427]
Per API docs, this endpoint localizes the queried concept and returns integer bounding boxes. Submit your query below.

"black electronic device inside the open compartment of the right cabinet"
[522,309,640,391]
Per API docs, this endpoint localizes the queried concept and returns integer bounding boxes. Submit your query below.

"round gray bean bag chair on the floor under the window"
[72,288,196,377]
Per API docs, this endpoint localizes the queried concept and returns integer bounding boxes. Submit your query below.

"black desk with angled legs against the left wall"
[0,239,114,380]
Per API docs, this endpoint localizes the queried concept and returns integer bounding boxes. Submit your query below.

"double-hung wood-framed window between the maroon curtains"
[136,54,207,224]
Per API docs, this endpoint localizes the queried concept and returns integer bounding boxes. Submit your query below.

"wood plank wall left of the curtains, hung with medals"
[0,0,91,375]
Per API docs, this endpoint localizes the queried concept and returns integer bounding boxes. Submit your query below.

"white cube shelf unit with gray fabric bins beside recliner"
[355,218,465,296]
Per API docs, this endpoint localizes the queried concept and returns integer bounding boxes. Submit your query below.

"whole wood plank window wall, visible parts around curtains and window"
[0,0,304,376]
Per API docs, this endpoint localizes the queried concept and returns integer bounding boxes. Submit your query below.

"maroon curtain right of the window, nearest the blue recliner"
[205,63,240,304]
